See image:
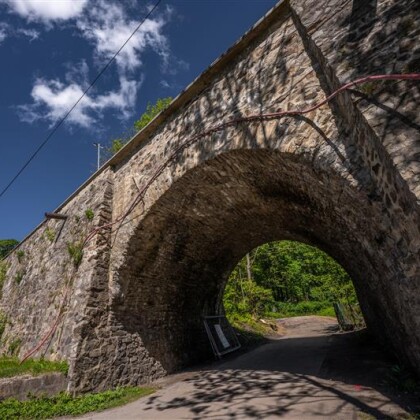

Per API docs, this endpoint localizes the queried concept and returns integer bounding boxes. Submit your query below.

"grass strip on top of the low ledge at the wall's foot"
[0,357,68,378]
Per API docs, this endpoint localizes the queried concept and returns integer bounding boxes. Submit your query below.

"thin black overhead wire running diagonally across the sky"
[0,0,162,198]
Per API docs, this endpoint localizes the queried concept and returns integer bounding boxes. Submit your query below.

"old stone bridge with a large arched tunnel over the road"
[1,0,420,391]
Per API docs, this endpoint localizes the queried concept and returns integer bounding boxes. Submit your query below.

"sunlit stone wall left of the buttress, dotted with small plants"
[1,171,112,370]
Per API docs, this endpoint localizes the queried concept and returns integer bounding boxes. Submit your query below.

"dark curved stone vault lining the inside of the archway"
[112,150,416,378]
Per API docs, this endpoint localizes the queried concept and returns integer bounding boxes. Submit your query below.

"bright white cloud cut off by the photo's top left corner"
[1,0,87,22]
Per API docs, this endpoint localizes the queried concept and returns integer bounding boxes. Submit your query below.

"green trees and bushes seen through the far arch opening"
[224,241,364,330]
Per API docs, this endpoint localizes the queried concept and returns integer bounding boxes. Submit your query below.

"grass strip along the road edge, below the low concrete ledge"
[0,387,154,419]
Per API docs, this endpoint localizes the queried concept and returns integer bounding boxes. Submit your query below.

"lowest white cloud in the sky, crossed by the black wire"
[17,78,142,128]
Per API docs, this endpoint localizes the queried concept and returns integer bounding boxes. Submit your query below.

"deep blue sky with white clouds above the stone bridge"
[0,0,277,240]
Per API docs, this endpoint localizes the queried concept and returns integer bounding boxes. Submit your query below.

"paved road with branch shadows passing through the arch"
[78,317,407,420]
